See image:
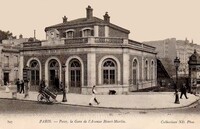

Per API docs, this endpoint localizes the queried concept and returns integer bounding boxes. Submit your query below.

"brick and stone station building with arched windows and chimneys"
[12,6,157,94]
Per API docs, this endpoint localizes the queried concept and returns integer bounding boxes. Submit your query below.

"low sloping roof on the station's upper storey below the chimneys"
[45,17,130,33]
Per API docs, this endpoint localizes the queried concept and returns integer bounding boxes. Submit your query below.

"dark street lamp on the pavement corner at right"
[174,57,180,104]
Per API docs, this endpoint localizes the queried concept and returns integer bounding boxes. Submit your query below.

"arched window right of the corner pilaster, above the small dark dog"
[103,59,117,84]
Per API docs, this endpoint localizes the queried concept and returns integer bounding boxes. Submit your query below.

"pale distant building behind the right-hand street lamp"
[143,38,200,76]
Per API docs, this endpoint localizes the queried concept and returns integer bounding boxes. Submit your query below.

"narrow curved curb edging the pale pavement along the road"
[0,98,200,110]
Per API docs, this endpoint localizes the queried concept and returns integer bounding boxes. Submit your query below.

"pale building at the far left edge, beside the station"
[0,35,28,85]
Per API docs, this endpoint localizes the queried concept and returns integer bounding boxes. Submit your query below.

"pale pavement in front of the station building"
[0,86,200,110]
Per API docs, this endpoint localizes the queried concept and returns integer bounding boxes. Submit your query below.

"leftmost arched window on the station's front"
[30,60,40,85]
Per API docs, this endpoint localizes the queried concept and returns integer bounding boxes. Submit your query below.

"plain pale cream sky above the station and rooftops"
[0,0,200,44]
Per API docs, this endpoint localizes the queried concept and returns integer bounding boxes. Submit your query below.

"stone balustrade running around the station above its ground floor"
[23,37,155,52]
